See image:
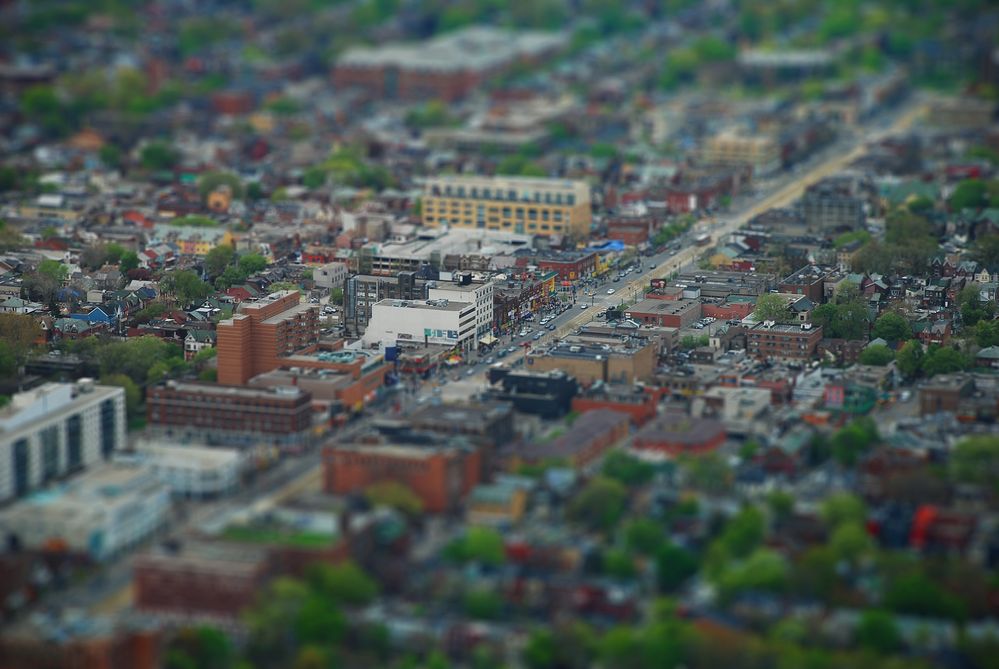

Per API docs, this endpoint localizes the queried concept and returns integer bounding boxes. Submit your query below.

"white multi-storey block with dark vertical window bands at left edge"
[0,379,126,503]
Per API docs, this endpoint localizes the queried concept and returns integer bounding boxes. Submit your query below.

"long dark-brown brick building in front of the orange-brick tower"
[146,381,312,445]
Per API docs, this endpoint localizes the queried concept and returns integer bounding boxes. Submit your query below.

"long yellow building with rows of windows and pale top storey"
[423,176,592,239]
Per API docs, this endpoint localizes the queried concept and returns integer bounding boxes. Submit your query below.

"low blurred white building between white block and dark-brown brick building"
[115,440,244,498]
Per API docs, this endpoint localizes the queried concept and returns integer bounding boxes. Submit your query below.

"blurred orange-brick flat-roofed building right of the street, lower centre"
[323,443,482,513]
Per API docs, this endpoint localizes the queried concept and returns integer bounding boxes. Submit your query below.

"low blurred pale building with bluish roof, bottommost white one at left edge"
[0,464,170,560]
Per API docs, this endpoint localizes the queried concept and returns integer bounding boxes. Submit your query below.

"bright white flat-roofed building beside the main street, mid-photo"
[363,299,476,351]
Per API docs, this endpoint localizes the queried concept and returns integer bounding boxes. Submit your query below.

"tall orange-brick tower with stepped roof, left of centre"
[216,290,319,386]
